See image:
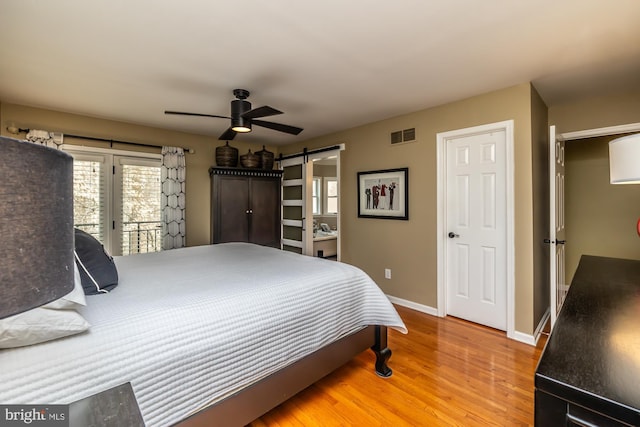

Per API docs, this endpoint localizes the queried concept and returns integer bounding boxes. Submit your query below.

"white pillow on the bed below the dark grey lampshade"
[0,262,90,348]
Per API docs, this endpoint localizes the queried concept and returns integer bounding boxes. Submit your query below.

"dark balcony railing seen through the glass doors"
[75,221,162,255]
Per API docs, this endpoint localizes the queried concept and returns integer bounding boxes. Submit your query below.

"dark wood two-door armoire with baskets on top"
[209,168,282,248]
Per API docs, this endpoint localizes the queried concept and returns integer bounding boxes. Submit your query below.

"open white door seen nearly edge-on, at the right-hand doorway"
[546,126,569,327]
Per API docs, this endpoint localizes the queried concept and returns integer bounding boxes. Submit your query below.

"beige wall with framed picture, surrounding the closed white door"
[281,83,534,334]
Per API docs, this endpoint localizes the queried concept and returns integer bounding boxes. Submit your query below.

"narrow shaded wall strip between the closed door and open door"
[531,87,551,326]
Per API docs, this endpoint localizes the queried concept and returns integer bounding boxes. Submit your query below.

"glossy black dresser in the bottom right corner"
[535,256,640,427]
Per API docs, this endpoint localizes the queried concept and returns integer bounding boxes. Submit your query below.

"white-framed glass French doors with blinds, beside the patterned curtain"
[65,147,162,255]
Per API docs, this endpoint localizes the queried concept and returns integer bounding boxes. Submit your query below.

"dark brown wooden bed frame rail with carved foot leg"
[177,326,392,427]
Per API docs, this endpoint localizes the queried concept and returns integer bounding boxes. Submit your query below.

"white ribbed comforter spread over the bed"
[0,243,406,426]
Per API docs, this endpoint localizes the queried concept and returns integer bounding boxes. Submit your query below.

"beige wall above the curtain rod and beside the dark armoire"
[0,103,277,246]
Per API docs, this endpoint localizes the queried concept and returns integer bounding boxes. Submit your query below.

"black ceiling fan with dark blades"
[164,89,303,140]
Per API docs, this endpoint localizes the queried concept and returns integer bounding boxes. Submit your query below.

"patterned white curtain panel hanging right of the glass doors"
[161,147,186,250]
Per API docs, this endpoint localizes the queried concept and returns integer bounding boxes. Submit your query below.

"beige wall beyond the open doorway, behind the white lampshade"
[565,136,640,281]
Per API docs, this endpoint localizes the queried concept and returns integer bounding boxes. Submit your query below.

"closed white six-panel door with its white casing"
[437,120,515,337]
